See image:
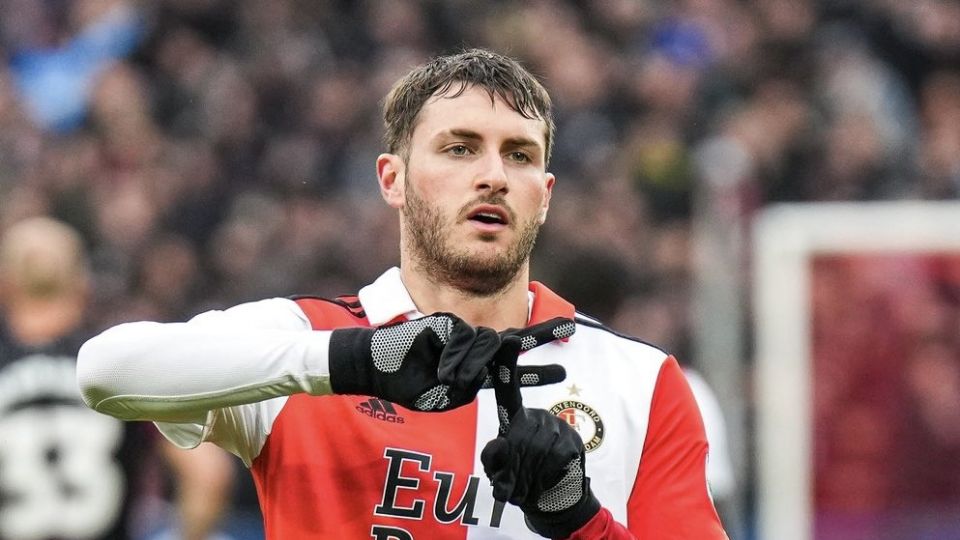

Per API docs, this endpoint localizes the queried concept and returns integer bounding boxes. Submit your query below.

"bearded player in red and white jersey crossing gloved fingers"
[78,49,726,540]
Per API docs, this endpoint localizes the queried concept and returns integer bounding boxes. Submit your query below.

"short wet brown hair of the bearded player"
[383,49,554,166]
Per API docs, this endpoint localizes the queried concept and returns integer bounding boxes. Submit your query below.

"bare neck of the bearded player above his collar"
[400,264,530,331]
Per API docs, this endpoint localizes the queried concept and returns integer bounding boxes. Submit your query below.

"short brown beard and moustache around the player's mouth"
[403,177,540,297]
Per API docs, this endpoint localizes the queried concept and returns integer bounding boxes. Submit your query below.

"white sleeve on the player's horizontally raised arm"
[77,298,331,465]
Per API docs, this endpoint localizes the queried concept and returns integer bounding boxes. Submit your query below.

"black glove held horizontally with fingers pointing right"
[330,313,575,411]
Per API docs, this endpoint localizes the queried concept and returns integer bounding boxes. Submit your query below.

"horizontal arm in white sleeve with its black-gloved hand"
[77,299,575,424]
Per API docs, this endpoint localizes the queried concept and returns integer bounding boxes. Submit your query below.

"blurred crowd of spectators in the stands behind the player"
[0,0,960,536]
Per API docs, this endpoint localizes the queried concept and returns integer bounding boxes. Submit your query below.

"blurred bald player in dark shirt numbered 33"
[0,217,233,540]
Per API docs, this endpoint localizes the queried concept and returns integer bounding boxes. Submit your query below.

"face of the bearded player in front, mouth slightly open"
[388,88,554,296]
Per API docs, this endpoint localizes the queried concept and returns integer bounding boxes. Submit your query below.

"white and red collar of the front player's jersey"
[357,266,575,326]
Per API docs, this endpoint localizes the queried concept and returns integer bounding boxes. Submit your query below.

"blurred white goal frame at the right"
[752,202,960,540]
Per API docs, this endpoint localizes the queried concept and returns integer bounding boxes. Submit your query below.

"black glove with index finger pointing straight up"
[480,338,600,538]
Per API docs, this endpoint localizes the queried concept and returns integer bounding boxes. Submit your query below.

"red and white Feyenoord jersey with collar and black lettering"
[142,269,726,540]
